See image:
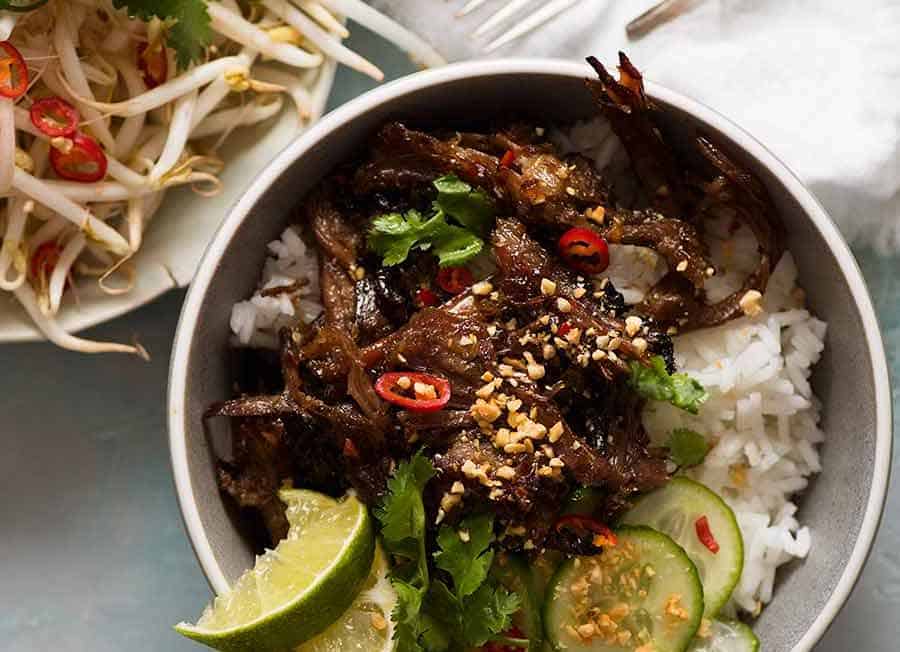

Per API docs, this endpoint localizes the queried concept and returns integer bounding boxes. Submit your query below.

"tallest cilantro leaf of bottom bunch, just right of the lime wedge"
[375,452,435,568]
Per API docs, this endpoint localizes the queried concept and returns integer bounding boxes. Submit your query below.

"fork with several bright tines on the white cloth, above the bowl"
[456,0,582,53]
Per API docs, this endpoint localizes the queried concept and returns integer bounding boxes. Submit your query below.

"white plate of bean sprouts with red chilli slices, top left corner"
[0,0,442,357]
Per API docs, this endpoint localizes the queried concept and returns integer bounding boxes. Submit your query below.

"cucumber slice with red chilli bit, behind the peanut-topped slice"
[622,477,744,619]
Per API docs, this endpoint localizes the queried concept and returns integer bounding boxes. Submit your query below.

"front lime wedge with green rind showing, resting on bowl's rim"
[175,489,375,652]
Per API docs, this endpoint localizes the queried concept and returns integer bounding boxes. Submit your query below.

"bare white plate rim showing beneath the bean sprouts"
[0,60,336,342]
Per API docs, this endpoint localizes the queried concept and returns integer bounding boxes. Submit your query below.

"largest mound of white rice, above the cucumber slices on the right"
[644,254,825,613]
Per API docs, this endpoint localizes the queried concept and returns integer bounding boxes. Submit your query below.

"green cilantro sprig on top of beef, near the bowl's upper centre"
[368,176,494,267]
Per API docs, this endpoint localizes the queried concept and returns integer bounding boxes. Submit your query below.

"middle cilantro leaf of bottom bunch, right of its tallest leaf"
[434,514,494,600]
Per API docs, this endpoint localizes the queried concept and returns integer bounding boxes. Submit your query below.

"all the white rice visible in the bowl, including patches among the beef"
[231,119,826,614]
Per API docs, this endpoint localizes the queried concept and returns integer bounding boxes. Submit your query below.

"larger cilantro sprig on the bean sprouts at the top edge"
[113,0,212,68]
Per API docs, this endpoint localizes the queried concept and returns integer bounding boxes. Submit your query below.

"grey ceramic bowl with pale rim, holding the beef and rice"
[169,60,891,652]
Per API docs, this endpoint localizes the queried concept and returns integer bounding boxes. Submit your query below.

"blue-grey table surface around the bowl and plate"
[0,28,900,652]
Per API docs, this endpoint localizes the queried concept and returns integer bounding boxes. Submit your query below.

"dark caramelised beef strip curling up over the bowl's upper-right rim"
[586,53,785,330]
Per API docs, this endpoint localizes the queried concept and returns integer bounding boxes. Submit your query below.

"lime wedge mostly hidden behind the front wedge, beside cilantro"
[294,546,397,652]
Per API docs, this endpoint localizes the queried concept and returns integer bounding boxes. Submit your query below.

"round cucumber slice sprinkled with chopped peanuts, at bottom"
[544,527,703,652]
